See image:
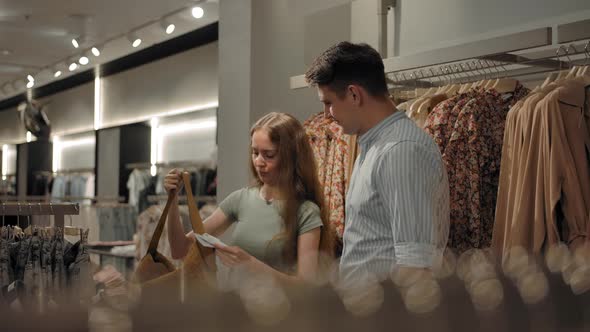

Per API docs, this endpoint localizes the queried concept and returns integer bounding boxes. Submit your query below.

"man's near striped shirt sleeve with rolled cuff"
[372,141,449,267]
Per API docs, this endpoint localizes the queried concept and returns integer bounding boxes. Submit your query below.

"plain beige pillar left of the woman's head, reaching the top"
[217,0,252,199]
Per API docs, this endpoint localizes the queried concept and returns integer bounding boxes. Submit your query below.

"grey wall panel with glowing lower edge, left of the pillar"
[101,42,218,127]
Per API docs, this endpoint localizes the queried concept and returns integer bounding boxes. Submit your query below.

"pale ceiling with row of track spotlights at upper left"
[0,0,219,100]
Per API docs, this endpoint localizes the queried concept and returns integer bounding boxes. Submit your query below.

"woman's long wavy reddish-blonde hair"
[250,112,335,264]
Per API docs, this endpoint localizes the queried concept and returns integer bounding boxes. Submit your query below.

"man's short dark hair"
[305,42,388,97]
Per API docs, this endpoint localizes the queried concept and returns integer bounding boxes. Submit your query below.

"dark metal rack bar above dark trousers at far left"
[0,202,80,228]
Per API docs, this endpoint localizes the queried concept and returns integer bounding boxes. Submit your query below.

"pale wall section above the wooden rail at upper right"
[398,0,590,55]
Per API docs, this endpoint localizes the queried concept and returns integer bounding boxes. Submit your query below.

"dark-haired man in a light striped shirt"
[305,42,449,282]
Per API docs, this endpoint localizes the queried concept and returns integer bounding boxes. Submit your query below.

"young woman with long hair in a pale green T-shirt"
[164,113,333,282]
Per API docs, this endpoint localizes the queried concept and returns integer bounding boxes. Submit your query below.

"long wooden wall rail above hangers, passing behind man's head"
[290,20,590,89]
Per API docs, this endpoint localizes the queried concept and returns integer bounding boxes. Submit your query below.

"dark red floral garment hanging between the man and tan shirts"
[425,84,528,253]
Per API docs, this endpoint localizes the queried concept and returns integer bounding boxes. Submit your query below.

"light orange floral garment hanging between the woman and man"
[303,113,352,239]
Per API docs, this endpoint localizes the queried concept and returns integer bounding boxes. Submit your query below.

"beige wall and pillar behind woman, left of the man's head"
[217,0,351,199]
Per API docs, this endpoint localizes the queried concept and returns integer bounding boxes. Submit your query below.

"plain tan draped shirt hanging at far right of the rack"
[494,80,590,253]
